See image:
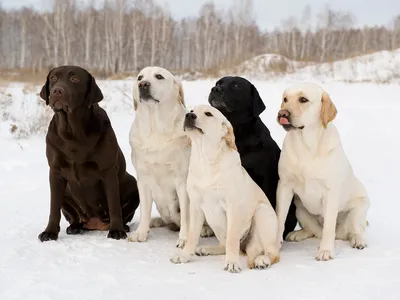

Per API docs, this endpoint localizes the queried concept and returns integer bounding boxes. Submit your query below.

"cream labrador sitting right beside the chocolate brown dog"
[128,67,212,248]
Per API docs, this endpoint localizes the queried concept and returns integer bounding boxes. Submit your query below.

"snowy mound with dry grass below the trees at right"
[234,49,400,83]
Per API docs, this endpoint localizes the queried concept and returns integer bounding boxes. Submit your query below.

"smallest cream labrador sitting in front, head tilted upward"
[171,105,279,272]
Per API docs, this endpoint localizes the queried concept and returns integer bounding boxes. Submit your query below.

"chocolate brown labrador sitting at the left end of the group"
[38,66,139,242]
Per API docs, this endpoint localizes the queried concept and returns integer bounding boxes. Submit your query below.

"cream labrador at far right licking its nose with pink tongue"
[277,83,369,260]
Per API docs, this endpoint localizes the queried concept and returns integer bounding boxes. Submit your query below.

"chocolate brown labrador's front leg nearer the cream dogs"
[103,168,127,240]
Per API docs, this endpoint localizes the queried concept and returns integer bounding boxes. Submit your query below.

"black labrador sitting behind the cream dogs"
[208,76,297,237]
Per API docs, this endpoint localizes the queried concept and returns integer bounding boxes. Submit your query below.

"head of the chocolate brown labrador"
[40,66,103,112]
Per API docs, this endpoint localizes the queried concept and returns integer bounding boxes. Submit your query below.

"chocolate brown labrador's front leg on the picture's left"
[38,169,67,242]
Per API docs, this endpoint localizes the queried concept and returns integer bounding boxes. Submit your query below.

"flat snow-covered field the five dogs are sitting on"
[0,80,400,300]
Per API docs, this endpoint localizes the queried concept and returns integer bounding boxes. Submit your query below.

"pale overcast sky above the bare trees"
[0,0,400,29]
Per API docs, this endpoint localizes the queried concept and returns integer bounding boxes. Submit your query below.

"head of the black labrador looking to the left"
[208,76,265,117]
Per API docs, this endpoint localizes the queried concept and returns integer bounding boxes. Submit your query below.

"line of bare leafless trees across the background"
[0,0,400,75]
